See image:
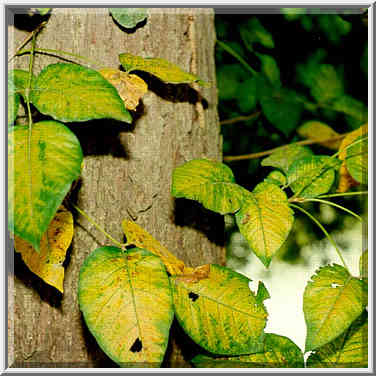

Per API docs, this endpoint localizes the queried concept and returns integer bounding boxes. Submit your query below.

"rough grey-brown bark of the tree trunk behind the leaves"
[9,9,224,367]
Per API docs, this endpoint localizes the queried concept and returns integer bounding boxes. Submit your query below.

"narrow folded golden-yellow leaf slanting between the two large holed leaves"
[122,220,187,275]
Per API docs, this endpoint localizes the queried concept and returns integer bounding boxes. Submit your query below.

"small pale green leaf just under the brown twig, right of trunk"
[261,144,313,173]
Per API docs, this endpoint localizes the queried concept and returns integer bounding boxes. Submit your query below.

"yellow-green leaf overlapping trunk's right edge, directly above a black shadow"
[171,159,247,214]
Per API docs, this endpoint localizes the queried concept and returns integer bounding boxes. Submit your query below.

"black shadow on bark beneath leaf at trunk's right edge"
[173,198,225,247]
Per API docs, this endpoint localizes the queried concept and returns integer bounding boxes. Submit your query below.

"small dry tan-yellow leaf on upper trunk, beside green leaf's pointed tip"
[99,68,148,110]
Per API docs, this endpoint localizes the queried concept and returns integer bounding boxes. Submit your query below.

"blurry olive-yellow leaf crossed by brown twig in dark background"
[297,120,341,150]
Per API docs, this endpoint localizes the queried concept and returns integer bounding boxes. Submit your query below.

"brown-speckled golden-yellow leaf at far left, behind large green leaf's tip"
[14,206,73,292]
